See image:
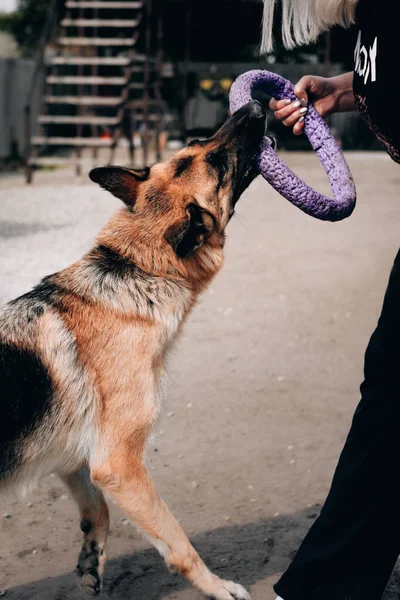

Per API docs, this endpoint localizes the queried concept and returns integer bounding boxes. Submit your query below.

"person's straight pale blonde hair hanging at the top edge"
[261,0,358,52]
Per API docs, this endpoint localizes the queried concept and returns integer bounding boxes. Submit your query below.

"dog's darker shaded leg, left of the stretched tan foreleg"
[62,466,109,596]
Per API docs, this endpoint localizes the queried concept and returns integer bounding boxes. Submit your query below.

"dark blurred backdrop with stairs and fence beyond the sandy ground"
[0,0,379,181]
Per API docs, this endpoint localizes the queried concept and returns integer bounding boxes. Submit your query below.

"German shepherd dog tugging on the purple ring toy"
[0,101,266,600]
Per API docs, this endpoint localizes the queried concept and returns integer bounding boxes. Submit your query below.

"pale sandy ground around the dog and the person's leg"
[0,154,400,600]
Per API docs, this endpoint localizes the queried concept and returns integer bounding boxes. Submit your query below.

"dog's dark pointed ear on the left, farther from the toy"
[89,167,150,206]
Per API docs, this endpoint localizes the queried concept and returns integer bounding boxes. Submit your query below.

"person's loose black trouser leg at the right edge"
[275,251,400,600]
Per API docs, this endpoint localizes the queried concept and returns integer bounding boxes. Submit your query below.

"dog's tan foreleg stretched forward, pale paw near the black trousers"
[92,447,250,600]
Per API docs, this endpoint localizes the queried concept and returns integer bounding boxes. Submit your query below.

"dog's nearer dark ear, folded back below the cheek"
[164,203,215,258]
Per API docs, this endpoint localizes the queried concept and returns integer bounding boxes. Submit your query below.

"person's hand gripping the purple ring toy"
[269,75,343,135]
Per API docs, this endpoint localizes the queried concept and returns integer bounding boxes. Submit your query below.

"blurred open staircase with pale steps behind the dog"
[27,0,155,182]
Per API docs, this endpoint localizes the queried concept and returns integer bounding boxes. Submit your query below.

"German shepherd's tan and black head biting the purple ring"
[90,101,266,284]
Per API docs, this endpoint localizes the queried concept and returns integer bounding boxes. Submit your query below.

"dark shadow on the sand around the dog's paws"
[7,505,400,600]
